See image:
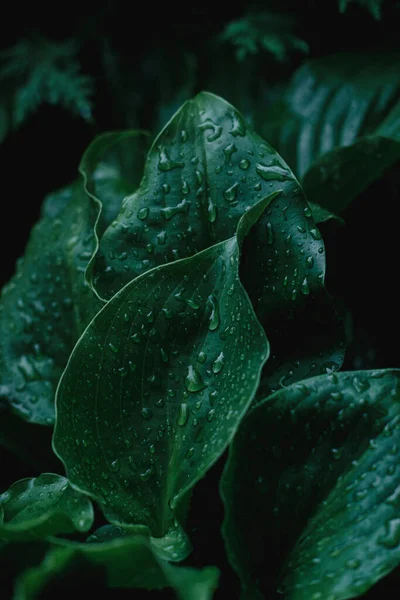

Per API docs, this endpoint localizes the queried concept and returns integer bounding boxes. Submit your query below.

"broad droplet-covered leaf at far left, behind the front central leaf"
[0,183,102,425]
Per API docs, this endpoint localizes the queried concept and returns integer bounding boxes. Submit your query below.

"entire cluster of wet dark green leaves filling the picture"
[0,2,400,600]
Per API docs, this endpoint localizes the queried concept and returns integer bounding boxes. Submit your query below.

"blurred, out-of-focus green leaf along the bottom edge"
[13,536,219,600]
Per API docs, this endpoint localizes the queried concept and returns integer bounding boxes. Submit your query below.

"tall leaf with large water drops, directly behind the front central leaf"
[86,92,344,393]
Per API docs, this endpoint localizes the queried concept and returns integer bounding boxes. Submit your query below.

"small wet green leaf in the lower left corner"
[0,473,94,540]
